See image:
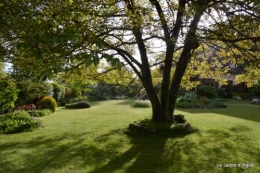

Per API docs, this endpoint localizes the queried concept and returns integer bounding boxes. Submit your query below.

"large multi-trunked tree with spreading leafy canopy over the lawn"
[1,0,260,122]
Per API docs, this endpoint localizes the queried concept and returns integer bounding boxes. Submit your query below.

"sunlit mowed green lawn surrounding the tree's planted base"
[0,100,260,173]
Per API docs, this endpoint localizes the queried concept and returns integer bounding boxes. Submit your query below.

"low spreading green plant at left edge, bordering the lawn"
[0,111,40,133]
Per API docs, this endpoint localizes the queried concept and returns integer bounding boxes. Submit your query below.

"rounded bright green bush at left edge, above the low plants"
[0,77,19,111]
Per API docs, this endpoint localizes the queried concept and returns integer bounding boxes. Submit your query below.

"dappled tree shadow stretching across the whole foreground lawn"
[0,126,260,173]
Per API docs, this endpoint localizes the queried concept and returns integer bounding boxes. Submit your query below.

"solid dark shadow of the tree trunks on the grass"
[91,125,193,173]
